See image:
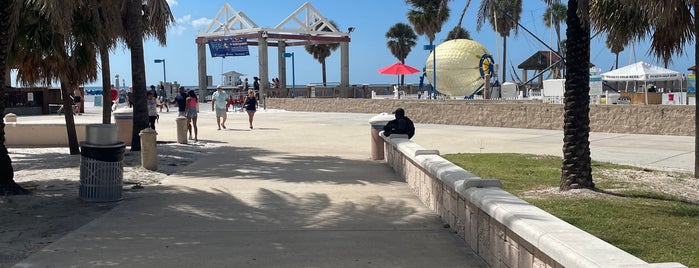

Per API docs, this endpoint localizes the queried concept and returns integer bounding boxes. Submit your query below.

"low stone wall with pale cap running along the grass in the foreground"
[384,134,686,268]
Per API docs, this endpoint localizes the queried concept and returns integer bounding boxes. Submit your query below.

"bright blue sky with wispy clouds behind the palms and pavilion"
[13,0,694,87]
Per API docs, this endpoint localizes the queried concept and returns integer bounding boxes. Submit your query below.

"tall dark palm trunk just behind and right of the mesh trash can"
[126,0,148,151]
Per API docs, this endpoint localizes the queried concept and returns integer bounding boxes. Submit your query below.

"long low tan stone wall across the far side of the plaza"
[266,98,696,136]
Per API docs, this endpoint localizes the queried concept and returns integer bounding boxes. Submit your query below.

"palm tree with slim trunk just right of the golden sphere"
[476,0,522,82]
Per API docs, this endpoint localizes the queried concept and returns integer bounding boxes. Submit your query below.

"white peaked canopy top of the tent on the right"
[602,61,682,81]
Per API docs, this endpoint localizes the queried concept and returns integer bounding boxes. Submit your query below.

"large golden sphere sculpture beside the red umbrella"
[425,39,495,96]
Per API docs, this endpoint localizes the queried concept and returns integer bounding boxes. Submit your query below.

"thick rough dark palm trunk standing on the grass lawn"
[559,0,595,191]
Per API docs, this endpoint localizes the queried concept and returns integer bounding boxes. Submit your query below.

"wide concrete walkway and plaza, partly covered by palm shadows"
[10,104,694,267]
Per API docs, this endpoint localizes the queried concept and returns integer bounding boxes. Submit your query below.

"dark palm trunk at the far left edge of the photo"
[0,0,29,195]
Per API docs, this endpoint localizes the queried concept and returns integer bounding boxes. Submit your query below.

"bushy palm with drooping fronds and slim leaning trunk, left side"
[9,1,99,154]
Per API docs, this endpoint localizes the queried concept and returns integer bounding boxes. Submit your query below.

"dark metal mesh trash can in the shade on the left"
[78,142,126,202]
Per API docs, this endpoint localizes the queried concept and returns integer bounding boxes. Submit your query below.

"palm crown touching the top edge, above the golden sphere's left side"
[405,0,449,45]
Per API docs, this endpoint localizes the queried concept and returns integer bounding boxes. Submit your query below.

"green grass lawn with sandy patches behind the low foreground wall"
[444,154,699,267]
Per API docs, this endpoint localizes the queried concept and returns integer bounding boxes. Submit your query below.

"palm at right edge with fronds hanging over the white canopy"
[590,0,699,178]
